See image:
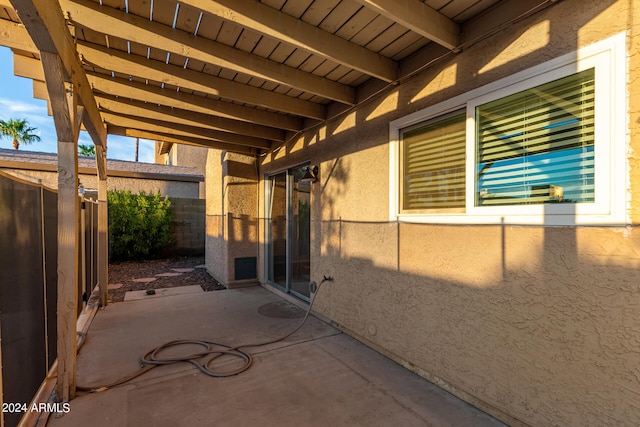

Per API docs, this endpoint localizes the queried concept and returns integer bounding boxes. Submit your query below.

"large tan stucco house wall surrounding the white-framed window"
[251,0,640,426]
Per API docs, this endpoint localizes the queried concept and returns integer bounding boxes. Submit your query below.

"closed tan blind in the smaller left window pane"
[401,113,465,210]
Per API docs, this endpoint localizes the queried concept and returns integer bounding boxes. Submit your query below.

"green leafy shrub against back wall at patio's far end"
[107,190,173,261]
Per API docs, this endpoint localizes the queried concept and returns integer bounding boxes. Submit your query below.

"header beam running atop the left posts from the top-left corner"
[11,0,107,179]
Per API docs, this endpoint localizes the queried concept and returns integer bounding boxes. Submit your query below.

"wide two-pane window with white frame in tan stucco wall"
[390,34,627,225]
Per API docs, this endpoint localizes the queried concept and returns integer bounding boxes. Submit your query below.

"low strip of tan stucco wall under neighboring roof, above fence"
[3,169,200,199]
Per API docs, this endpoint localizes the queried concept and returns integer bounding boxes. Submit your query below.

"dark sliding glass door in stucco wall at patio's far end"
[266,165,311,300]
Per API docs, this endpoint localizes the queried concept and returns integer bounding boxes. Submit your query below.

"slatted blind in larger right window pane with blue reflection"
[476,68,595,205]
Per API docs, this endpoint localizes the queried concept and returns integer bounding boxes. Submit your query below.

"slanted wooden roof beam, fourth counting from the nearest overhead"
[78,42,326,120]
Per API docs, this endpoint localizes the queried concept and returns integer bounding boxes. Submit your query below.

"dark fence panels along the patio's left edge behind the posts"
[0,172,98,427]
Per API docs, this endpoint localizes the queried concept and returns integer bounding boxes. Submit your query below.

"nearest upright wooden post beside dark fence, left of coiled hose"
[41,51,80,402]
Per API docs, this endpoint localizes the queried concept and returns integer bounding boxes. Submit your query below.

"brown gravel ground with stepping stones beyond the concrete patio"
[108,257,225,303]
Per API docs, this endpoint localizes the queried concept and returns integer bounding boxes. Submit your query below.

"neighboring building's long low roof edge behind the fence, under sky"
[0,149,204,182]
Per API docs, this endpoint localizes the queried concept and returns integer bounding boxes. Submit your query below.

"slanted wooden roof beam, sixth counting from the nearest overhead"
[96,94,285,142]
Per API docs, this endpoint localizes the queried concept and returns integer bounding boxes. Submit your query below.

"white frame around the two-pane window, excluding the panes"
[389,33,629,225]
